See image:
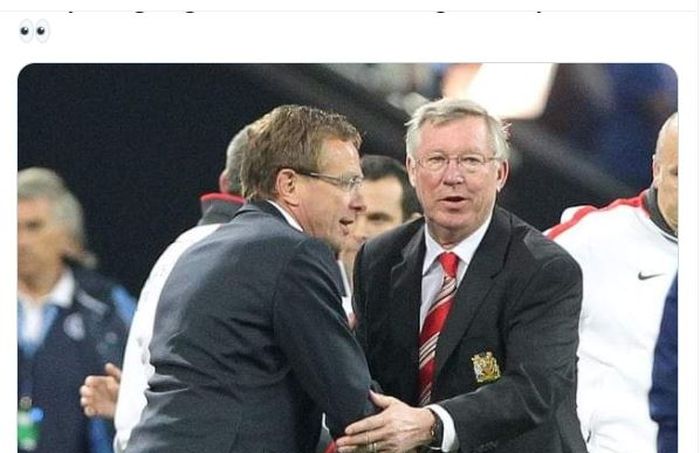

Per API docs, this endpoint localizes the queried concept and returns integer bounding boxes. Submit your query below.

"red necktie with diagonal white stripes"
[418,252,459,406]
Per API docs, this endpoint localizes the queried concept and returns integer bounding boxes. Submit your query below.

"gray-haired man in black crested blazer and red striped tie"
[337,99,585,453]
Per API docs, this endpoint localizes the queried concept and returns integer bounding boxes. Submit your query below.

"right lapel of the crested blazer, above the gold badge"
[435,207,510,377]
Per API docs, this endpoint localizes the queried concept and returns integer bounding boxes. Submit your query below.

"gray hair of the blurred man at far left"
[17,167,95,266]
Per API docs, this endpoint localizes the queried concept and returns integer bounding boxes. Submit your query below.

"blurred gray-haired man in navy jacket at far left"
[17,167,134,453]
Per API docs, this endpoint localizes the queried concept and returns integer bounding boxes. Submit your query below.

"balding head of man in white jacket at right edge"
[652,112,678,233]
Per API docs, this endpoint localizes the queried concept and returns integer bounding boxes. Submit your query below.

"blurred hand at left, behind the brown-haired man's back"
[80,363,122,418]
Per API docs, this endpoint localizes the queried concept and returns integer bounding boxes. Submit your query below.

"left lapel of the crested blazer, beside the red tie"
[389,227,425,399]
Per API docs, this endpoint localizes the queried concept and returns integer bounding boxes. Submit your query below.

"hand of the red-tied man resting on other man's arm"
[336,392,435,453]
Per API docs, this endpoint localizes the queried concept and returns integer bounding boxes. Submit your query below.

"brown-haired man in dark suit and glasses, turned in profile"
[126,106,374,453]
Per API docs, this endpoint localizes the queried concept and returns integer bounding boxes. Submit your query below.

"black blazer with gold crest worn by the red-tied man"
[354,207,586,453]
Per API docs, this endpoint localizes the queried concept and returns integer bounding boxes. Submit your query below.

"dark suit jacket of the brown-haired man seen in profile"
[127,203,374,453]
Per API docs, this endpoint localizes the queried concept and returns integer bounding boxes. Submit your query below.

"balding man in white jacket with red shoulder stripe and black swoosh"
[547,113,678,453]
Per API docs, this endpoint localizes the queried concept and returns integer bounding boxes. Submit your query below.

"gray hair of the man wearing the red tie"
[406,98,510,160]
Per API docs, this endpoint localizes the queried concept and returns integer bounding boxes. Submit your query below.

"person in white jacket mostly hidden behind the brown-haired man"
[80,120,261,452]
